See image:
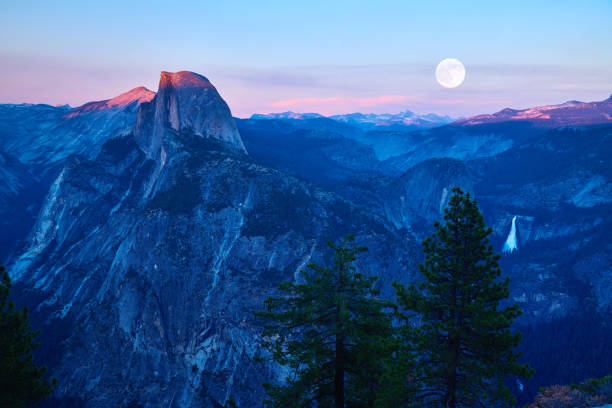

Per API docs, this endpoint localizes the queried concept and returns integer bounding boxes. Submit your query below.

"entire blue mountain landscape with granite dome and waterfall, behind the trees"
[0,71,612,408]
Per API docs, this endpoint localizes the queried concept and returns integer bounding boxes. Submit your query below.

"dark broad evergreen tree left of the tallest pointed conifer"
[257,236,393,408]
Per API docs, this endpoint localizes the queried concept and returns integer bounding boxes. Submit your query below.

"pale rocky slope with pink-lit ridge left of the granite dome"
[0,87,155,261]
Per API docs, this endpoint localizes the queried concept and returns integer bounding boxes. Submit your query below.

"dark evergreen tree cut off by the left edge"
[0,266,55,408]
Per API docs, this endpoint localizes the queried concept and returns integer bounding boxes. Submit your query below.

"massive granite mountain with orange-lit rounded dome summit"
[10,73,418,407]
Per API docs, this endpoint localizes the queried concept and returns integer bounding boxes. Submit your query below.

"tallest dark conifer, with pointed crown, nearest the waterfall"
[395,188,532,408]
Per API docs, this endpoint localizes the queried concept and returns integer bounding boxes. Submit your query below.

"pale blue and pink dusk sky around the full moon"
[0,0,612,117]
